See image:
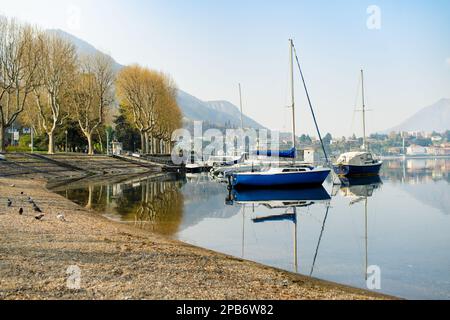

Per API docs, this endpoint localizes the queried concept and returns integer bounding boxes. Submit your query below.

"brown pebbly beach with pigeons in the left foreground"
[0,178,389,300]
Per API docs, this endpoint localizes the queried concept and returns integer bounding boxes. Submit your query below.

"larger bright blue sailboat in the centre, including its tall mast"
[230,39,331,188]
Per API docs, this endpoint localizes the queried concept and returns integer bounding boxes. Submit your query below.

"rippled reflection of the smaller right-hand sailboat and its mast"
[340,176,383,281]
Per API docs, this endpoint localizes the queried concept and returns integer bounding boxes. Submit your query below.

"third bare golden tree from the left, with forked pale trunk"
[73,53,115,155]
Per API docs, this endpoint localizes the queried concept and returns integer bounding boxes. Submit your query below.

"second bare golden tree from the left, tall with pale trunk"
[33,33,77,154]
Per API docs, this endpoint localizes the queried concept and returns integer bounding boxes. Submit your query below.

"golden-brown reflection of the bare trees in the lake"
[54,175,185,236]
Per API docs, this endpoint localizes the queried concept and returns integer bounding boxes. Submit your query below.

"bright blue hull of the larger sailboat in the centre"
[231,169,331,188]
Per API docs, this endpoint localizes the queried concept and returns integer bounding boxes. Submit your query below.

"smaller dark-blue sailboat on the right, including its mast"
[333,70,383,177]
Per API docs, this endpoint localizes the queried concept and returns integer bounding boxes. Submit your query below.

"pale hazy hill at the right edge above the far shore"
[385,99,450,133]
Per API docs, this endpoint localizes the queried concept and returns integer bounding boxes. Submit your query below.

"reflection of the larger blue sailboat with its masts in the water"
[226,187,331,274]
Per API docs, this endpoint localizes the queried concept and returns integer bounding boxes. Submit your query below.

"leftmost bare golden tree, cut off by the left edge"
[0,17,41,152]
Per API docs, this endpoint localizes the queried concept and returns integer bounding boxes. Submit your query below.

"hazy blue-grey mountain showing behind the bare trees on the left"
[47,29,264,129]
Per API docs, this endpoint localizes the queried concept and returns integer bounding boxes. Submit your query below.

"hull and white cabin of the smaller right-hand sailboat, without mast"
[333,152,383,177]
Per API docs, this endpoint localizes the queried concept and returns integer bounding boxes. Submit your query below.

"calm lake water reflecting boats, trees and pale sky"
[55,159,450,299]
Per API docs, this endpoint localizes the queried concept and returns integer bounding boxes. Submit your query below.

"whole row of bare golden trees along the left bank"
[0,18,181,155]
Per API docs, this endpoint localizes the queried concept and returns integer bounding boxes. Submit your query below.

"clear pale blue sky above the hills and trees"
[0,0,450,136]
